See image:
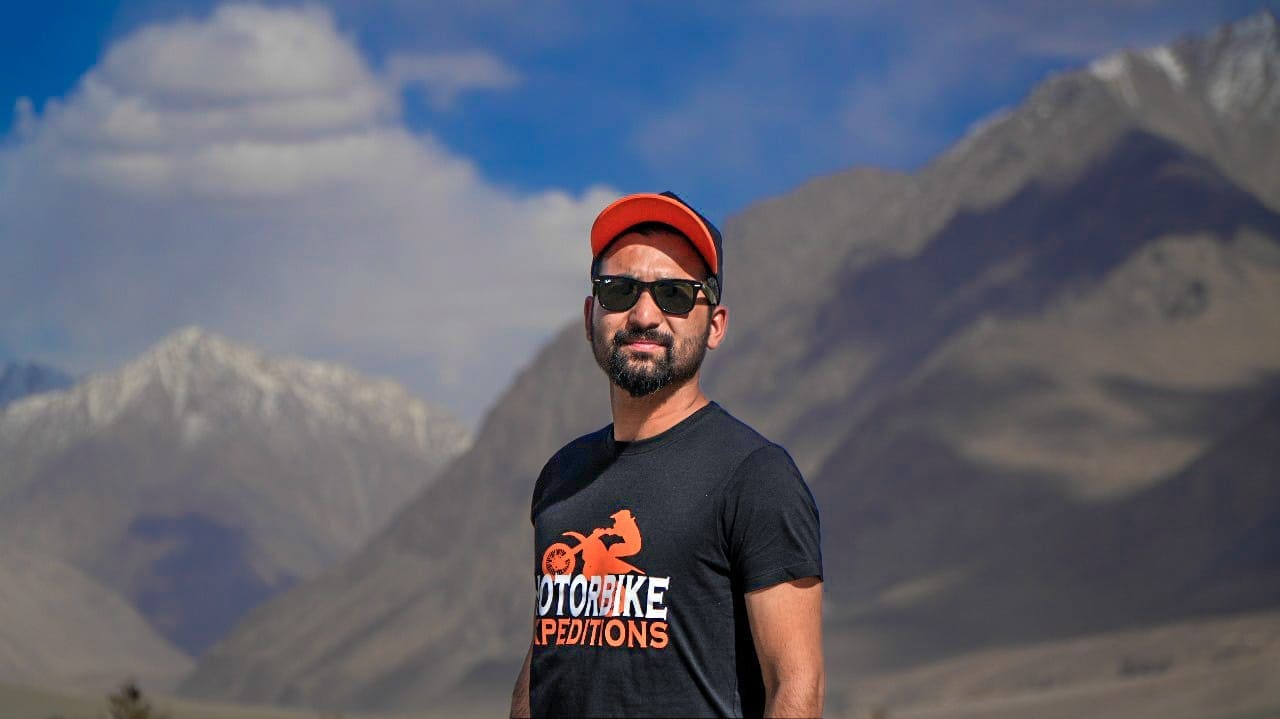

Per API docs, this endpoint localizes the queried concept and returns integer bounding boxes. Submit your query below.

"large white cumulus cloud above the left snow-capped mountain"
[0,5,614,412]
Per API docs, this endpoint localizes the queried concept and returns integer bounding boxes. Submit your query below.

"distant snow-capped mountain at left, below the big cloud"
[0,328,468,655]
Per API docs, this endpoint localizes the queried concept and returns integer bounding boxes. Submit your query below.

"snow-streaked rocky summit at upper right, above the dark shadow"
[942,12,1280,217]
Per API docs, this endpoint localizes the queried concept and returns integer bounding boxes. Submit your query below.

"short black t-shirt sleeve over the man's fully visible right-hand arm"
[723,445,822,591]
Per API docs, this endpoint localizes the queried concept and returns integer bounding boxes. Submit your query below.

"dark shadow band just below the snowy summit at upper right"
[797,132,1280,432]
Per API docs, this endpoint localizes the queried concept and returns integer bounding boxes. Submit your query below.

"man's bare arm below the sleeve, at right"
[746,577,827,716]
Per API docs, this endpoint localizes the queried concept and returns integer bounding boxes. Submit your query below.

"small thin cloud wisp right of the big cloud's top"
[387,50,520,109]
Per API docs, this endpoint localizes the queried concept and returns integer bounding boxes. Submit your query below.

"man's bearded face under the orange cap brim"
[588,229,723,397]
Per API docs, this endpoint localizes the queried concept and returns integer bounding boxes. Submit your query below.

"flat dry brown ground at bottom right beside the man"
[828,612,1280,719]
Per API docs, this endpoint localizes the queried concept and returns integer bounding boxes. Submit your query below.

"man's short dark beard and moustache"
[591,322,712,397]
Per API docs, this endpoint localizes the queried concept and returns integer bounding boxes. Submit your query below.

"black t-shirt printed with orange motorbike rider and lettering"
[529,403,822,716]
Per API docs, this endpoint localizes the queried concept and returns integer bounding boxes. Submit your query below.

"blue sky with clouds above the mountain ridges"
[0,0,1280,420]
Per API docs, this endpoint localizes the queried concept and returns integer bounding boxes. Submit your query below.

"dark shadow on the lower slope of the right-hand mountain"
[819,379,1280,669]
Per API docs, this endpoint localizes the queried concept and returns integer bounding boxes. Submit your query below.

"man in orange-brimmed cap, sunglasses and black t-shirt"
[511,193,824,716]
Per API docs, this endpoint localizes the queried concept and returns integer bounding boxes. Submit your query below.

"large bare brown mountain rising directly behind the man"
[184,13,1280,710]
